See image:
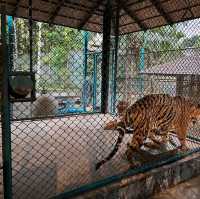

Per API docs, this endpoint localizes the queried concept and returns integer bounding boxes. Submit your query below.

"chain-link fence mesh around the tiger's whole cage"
[1,15,200,199]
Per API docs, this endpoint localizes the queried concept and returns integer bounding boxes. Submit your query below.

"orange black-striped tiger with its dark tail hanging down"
[96,94,200,170]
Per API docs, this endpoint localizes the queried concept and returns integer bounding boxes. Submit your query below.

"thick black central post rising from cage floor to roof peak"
[101,0,112,113]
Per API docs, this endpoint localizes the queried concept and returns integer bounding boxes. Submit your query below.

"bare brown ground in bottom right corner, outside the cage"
[150,176,200,199]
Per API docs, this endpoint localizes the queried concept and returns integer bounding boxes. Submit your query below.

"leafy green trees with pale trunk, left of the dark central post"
[15,19,83,89]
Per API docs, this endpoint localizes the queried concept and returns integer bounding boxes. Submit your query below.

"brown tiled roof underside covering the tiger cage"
[0,0,200,34]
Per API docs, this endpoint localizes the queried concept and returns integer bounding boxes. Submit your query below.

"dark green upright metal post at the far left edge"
[1,14,12,199]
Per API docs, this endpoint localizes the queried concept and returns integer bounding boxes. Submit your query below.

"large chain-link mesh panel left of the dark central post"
[9,19,114,199]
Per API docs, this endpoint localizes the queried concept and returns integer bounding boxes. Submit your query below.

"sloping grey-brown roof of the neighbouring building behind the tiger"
[140,51,200,76]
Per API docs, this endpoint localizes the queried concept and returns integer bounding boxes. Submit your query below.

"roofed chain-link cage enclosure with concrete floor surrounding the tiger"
[0,0,200,199]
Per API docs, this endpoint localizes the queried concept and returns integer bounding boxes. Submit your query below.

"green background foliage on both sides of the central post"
[14,19,200,90]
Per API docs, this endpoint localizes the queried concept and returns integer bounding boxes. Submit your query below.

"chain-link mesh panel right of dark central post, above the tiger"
[114,20,199,162]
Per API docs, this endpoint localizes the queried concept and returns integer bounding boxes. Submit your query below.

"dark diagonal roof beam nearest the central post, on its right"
[119,1,147,30]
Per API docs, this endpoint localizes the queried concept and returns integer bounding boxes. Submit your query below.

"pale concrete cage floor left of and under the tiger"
[0,114,200,199]
